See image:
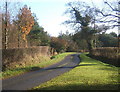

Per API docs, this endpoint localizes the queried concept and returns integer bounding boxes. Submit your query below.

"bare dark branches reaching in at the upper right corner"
[96,1,120,28]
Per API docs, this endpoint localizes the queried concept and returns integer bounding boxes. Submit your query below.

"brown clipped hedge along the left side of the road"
[1,46,53,70]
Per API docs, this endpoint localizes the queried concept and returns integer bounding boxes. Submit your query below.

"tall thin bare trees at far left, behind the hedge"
[0,0,20,49]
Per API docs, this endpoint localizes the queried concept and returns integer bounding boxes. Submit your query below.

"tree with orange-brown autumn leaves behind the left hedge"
[18,5,34,47]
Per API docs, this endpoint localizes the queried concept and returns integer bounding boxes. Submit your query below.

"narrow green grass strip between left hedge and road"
[0,52,74,79]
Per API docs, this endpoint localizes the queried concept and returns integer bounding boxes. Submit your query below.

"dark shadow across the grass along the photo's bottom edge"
[34,83,119,92]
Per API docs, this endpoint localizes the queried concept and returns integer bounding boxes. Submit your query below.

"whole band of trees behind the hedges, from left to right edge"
[0,1,120,52]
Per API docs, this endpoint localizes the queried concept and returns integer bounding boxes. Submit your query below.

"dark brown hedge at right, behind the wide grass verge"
[90,47,120,66]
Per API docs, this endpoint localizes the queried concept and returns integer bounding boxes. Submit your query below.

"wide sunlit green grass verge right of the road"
[32,54,120,90]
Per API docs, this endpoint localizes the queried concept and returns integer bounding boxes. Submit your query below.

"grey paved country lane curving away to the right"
[2,54,80,91]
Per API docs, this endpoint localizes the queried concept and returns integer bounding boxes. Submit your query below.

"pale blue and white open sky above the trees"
[0,0,117,36]
